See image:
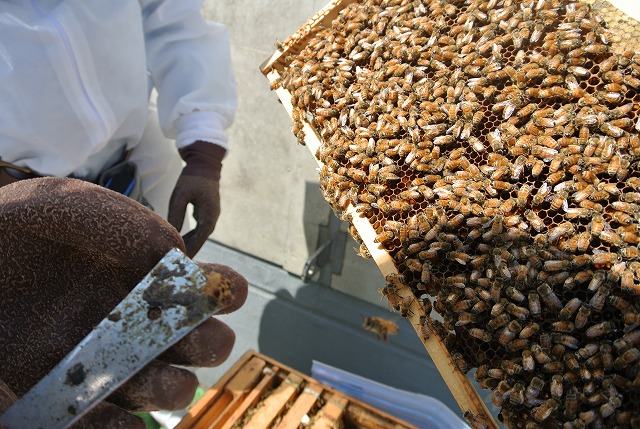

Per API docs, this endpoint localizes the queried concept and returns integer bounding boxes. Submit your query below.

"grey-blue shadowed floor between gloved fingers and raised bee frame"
[190,241,470,415]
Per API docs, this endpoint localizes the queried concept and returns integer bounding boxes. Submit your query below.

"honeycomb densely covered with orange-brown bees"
[274,0,640,429]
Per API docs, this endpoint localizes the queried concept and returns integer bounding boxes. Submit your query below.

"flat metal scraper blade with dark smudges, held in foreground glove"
[0,249,222,429]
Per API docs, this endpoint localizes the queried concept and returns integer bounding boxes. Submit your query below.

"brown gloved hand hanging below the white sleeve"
[167,141,226,258]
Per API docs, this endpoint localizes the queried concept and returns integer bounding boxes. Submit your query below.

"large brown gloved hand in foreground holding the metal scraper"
[0,178,247,429]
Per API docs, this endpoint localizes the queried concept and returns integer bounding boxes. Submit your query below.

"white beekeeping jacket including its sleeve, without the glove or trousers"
[0,0,237,176]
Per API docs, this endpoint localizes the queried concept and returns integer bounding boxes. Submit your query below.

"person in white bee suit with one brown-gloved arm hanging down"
[0,0,237,256]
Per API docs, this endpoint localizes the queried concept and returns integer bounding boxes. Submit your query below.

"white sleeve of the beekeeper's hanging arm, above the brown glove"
[140,0,237,148]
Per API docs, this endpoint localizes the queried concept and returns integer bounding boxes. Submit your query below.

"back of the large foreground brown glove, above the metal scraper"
[0,178,185,396]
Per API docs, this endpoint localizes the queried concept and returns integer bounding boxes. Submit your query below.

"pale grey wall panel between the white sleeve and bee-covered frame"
[203,0,386,305]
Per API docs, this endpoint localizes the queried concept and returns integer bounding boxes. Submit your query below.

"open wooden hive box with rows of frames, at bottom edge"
[176,350,417,429]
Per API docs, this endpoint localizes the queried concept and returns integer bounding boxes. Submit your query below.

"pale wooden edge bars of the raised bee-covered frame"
[260,0,498,428]
